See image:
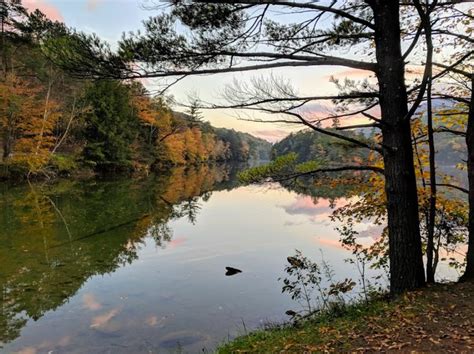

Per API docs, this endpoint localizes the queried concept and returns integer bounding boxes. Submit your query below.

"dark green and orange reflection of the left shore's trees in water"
[0,165,241,347]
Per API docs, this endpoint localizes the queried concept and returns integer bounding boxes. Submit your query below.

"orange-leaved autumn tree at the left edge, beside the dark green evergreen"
[0,1,88,177]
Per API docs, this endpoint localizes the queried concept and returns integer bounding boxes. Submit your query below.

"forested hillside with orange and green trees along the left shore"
[0,2,271,179]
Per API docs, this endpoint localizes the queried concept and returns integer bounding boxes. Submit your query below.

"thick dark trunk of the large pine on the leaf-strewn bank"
[369,0,425,294]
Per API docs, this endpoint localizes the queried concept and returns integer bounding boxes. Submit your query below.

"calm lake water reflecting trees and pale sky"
[0,167,456,353]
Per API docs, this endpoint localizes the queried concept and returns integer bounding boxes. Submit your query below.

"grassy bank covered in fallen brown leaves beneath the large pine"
[218,283,474,353]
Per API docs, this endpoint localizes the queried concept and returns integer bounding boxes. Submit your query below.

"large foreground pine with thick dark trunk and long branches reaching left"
[108,0,430,294]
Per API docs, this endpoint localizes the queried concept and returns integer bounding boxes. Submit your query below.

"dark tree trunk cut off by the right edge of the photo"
[461,76,474,281]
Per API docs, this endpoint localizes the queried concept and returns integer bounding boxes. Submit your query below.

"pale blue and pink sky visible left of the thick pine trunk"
[23,0,374,142]
